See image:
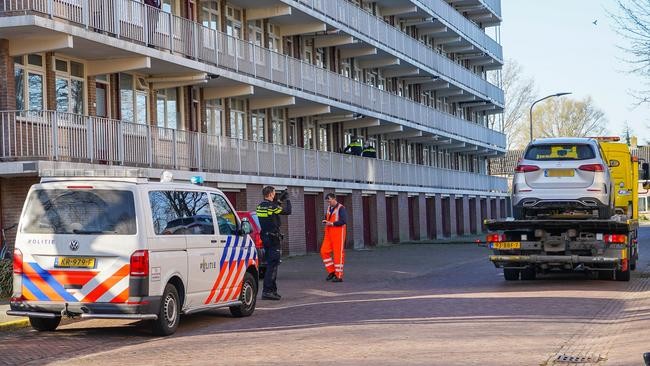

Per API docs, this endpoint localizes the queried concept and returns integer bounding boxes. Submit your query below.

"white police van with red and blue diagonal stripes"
[7,171,258,335]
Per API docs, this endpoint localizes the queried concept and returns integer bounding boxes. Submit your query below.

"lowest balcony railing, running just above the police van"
[0,111,507,192]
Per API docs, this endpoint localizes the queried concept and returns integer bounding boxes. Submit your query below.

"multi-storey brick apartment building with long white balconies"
[0,0,508,254]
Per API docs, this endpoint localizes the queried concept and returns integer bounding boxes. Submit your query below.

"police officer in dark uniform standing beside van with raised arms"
[256,186,291,300]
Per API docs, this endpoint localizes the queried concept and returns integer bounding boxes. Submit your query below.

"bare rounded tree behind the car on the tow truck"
[533,97,607,137]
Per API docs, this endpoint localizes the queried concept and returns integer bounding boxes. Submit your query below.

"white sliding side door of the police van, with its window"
[184,191,222,308]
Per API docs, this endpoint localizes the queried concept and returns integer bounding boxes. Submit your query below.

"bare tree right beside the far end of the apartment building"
[489,60,536,150]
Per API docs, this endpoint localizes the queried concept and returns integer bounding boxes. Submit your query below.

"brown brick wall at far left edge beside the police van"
[0,177,39,250]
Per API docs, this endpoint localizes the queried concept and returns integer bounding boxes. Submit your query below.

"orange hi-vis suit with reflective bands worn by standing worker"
[320,203,347,279]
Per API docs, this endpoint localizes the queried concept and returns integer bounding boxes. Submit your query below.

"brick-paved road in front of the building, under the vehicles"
[0,228,650,365]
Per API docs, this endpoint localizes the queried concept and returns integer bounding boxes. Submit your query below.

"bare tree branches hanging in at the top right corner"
[610,0,650,105]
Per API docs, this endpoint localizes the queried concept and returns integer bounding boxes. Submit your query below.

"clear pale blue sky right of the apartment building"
[500,0,650,144]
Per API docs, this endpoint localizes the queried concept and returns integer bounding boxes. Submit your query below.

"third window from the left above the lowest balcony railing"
[120,74,149,124]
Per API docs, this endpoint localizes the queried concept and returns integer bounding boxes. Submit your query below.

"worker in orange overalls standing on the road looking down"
[320,193,348,282]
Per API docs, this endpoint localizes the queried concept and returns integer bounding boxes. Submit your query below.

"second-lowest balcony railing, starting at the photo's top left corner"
[0,0,506,147]
